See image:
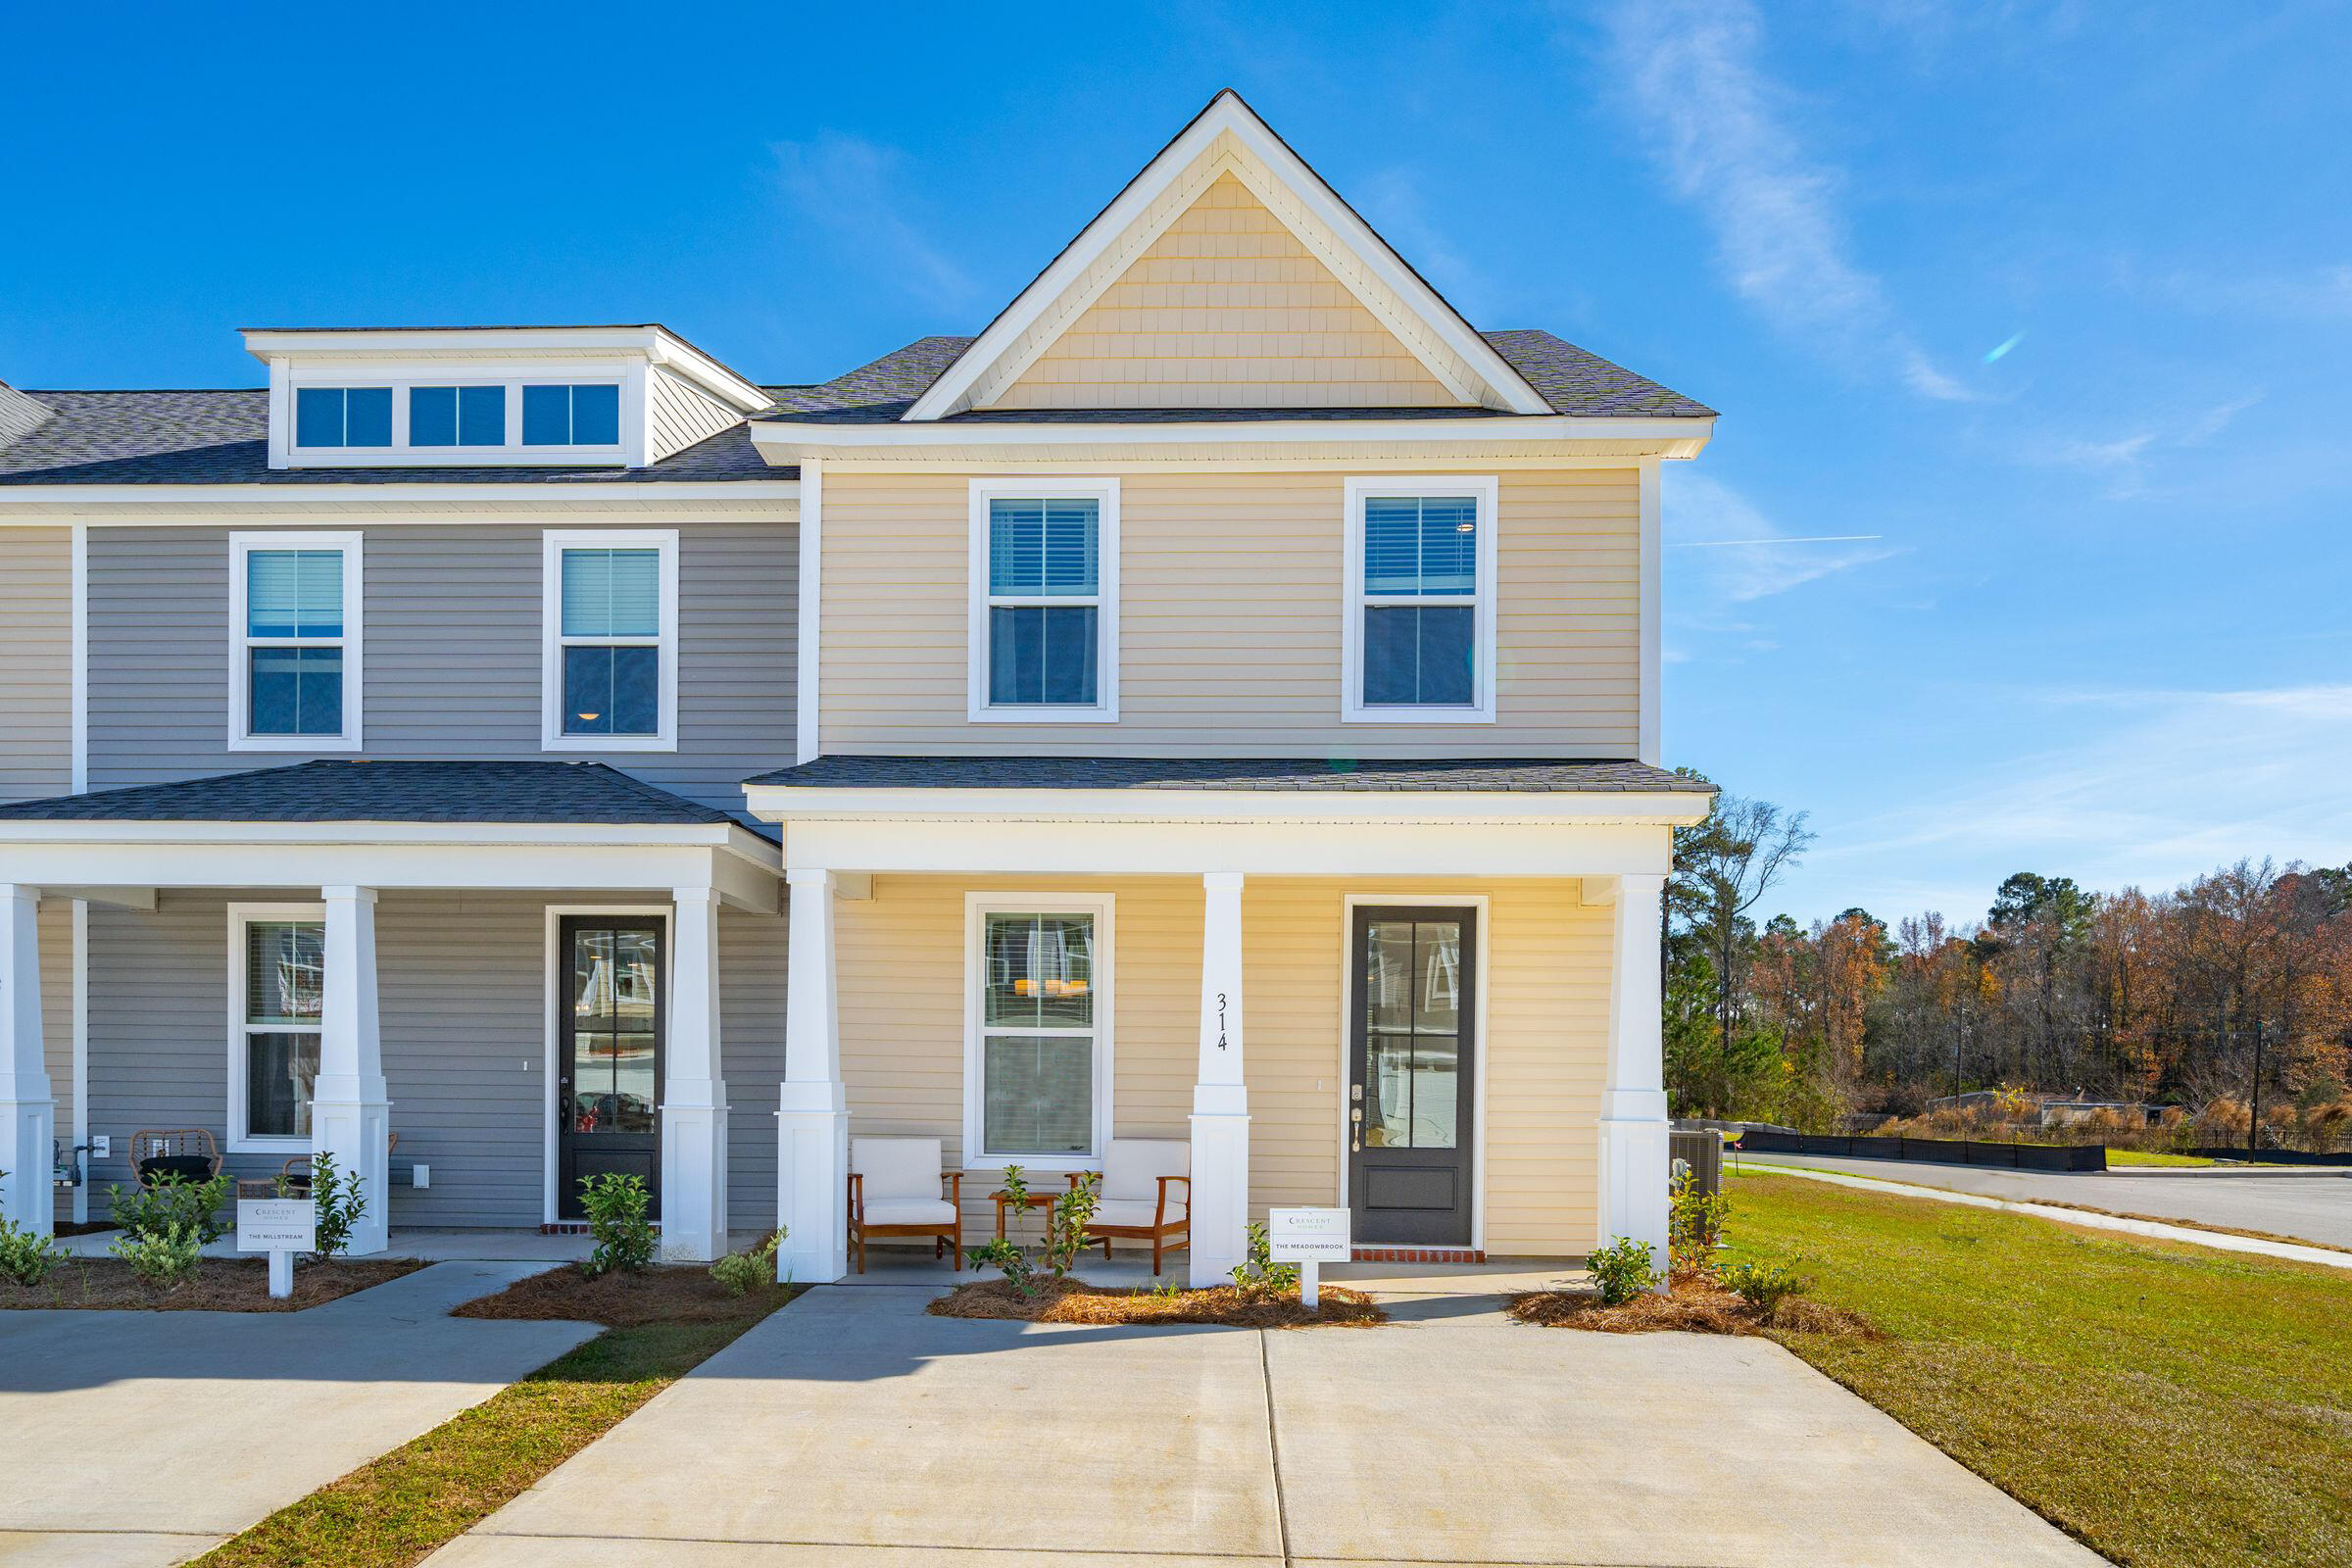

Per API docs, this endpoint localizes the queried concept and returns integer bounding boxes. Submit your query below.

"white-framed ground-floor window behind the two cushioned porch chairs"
[964,894,1110,1171]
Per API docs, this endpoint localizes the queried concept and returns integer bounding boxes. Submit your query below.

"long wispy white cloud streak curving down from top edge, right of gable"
[1606,0,1971,402]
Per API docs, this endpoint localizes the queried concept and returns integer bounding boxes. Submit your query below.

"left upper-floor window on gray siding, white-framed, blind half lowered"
[228,534,360,753]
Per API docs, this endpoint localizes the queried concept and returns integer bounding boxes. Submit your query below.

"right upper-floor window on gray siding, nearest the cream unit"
[541,529,677,753]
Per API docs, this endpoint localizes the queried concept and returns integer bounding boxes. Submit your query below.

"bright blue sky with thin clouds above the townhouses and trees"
[0,0,2352,919]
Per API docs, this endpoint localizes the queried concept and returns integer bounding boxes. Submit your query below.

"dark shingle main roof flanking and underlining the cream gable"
[755,331,1715,425]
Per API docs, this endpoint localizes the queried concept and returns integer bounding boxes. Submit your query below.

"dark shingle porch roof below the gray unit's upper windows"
[0,761,734,825]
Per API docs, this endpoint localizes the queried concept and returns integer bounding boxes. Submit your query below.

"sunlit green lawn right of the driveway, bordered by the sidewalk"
[1727,1171,2352,1568]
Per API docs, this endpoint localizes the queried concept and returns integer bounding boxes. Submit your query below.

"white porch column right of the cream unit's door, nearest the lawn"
[1594,874,1668,1269]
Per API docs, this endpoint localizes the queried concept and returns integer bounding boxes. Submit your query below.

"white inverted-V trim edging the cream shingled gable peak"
[901,87,1547,420]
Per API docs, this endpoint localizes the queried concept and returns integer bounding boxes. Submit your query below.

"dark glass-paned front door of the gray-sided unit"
[555,914,668,1220]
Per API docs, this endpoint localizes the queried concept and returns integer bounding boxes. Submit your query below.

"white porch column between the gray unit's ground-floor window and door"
[311,886,393,1257]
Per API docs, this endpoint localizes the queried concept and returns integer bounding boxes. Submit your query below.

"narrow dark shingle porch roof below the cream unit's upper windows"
[743,757,1715,795]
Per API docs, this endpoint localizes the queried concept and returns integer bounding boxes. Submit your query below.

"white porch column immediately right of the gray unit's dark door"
[661,889,727,1262]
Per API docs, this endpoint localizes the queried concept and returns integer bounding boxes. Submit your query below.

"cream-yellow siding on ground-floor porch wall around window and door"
[835,877,1609,1255]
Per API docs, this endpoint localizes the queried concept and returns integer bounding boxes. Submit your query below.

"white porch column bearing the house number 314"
[1186,872,1249,1286]
